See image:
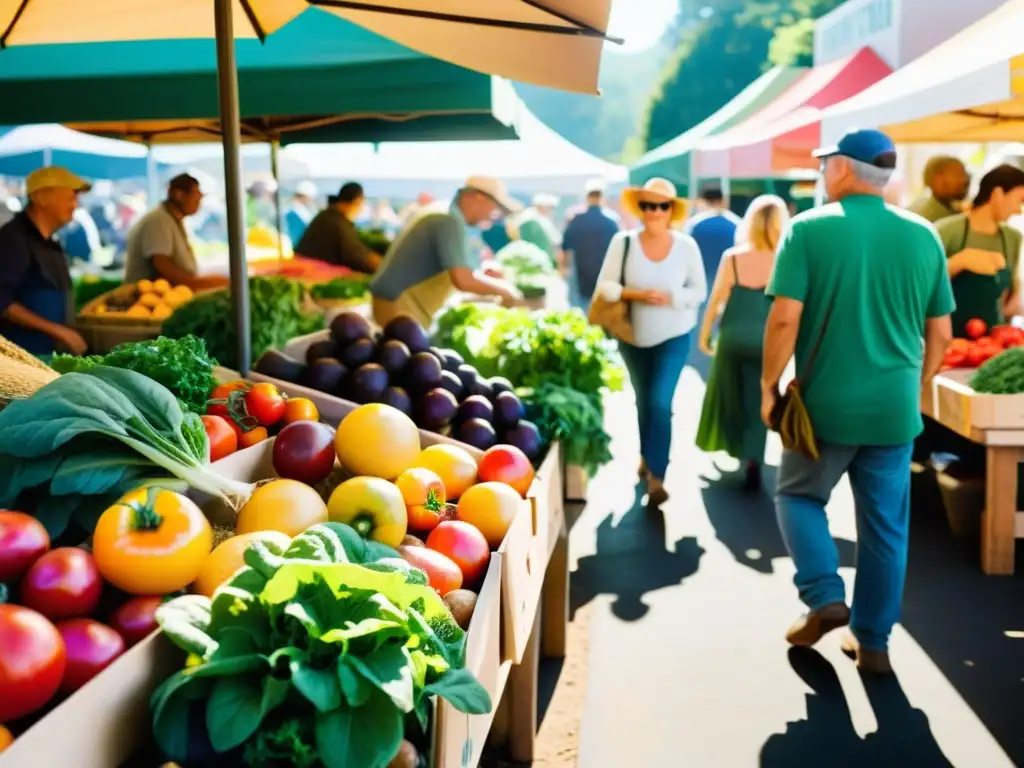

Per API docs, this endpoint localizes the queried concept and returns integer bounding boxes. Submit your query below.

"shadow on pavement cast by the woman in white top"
[569,486,705,622]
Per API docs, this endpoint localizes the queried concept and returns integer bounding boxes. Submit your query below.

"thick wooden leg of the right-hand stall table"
[981,446,1021,575]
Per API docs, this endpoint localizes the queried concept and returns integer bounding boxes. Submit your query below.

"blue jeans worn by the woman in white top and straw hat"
[618,334,690,480]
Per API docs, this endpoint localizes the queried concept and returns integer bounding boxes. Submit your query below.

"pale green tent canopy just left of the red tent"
[630,67,807,199]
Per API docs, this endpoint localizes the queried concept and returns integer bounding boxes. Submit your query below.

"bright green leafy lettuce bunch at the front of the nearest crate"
[151,523,492,768]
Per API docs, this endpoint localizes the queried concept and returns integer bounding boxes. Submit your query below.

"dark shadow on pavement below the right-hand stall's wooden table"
[897,509,1024,765]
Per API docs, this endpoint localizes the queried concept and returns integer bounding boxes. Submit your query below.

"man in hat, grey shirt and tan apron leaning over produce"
[370,176,522,328]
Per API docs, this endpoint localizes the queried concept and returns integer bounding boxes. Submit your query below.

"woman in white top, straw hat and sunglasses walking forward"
[597,178,708,507]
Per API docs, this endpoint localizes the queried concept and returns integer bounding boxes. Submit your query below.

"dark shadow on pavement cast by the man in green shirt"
[760,648,952,768]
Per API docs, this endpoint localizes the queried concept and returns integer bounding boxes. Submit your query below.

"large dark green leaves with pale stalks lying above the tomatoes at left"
[0,366,252,538]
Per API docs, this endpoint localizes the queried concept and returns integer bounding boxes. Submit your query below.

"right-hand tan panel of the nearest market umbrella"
[309,0,614,93]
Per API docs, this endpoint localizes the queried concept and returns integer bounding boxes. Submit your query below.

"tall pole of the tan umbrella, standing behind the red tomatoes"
[213,0,252,376]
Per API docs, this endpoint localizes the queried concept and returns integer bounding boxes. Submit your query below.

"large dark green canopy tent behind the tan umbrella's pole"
[0,9,518,143]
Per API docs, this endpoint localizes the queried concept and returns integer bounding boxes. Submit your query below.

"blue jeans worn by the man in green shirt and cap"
[775,442,913,650]
